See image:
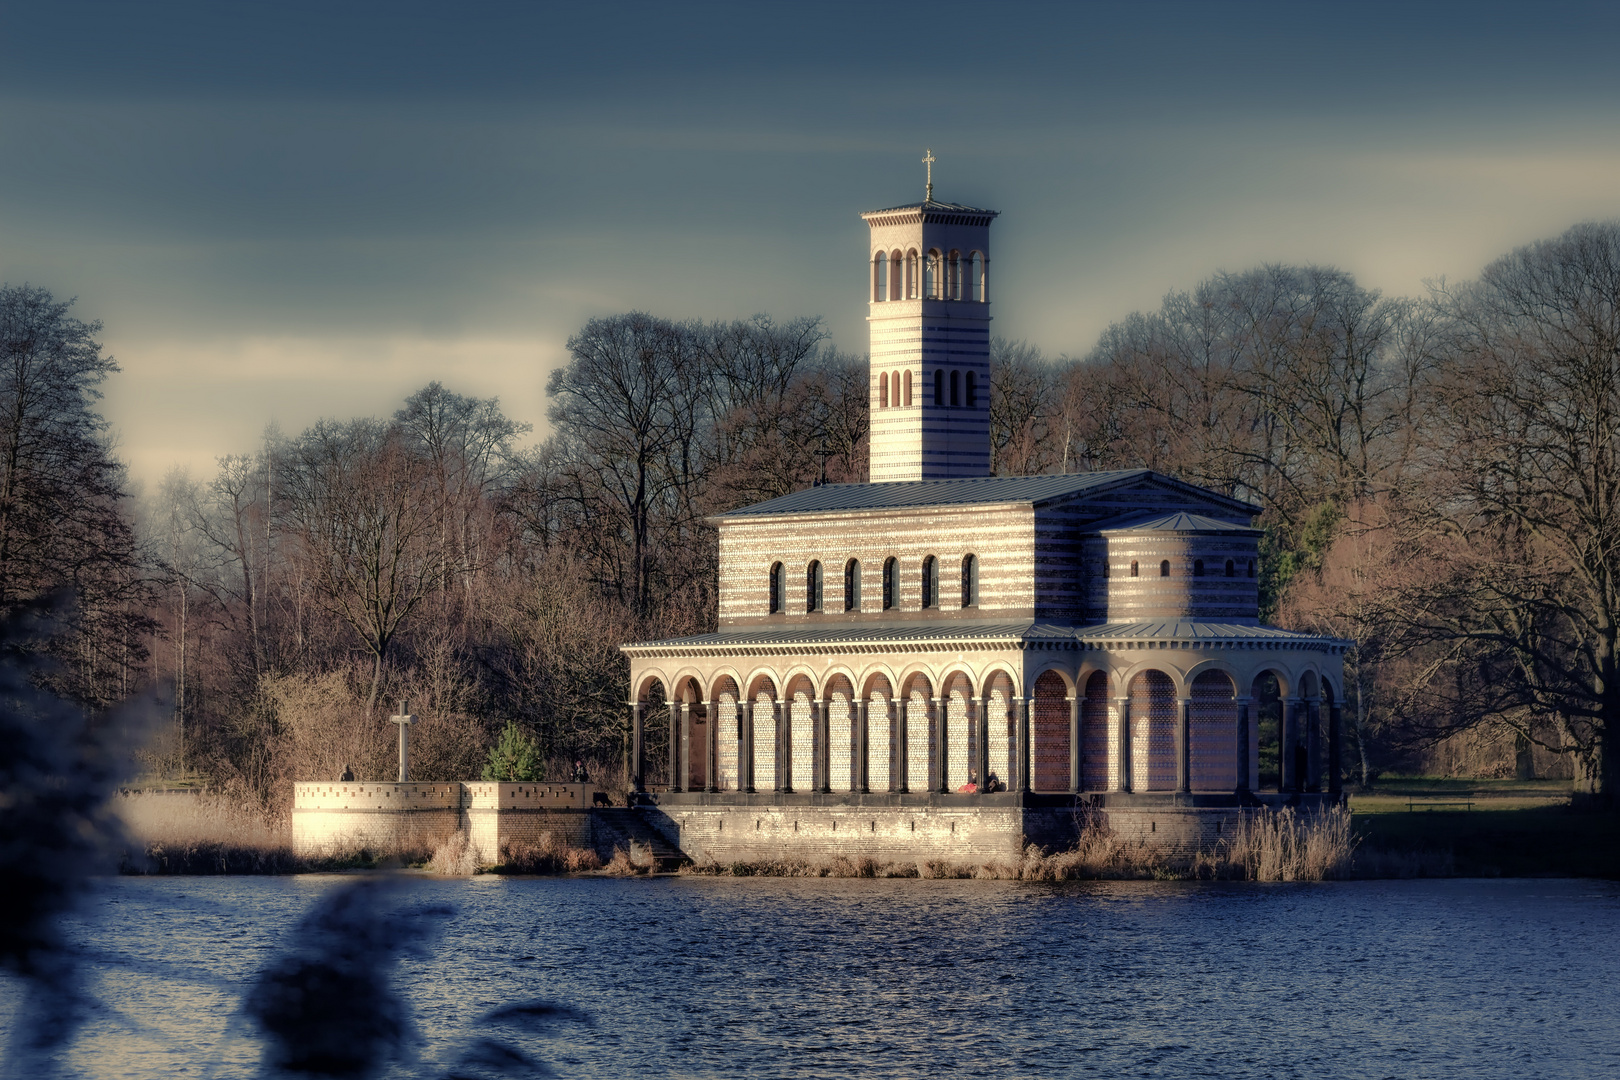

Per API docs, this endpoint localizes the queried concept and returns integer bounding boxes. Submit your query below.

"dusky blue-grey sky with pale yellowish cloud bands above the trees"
[0,0,1620,491]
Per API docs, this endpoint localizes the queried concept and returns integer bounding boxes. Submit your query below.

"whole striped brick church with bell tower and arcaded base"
[622,183,1349,860]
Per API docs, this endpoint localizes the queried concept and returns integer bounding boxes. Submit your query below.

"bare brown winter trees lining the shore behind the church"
[9,223,1620,805]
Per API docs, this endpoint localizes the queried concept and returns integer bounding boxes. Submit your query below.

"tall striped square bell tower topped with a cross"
[860,151,996,483]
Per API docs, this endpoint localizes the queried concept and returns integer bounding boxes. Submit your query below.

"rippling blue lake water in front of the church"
[0,876,1620,1078]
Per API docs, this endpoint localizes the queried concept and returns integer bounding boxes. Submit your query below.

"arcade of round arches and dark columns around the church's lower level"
[630,649,1341,793]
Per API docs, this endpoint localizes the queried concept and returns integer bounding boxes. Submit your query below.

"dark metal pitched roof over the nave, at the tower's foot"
[714,470,1159,518]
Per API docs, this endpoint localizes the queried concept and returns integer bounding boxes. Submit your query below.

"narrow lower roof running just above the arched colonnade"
[620,619,1349,656]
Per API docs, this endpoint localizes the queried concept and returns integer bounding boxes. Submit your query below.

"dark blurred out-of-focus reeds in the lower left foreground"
[0,601,590,1080]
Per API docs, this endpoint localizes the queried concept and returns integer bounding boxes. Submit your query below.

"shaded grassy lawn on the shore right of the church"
[1349,777,1620,878]
